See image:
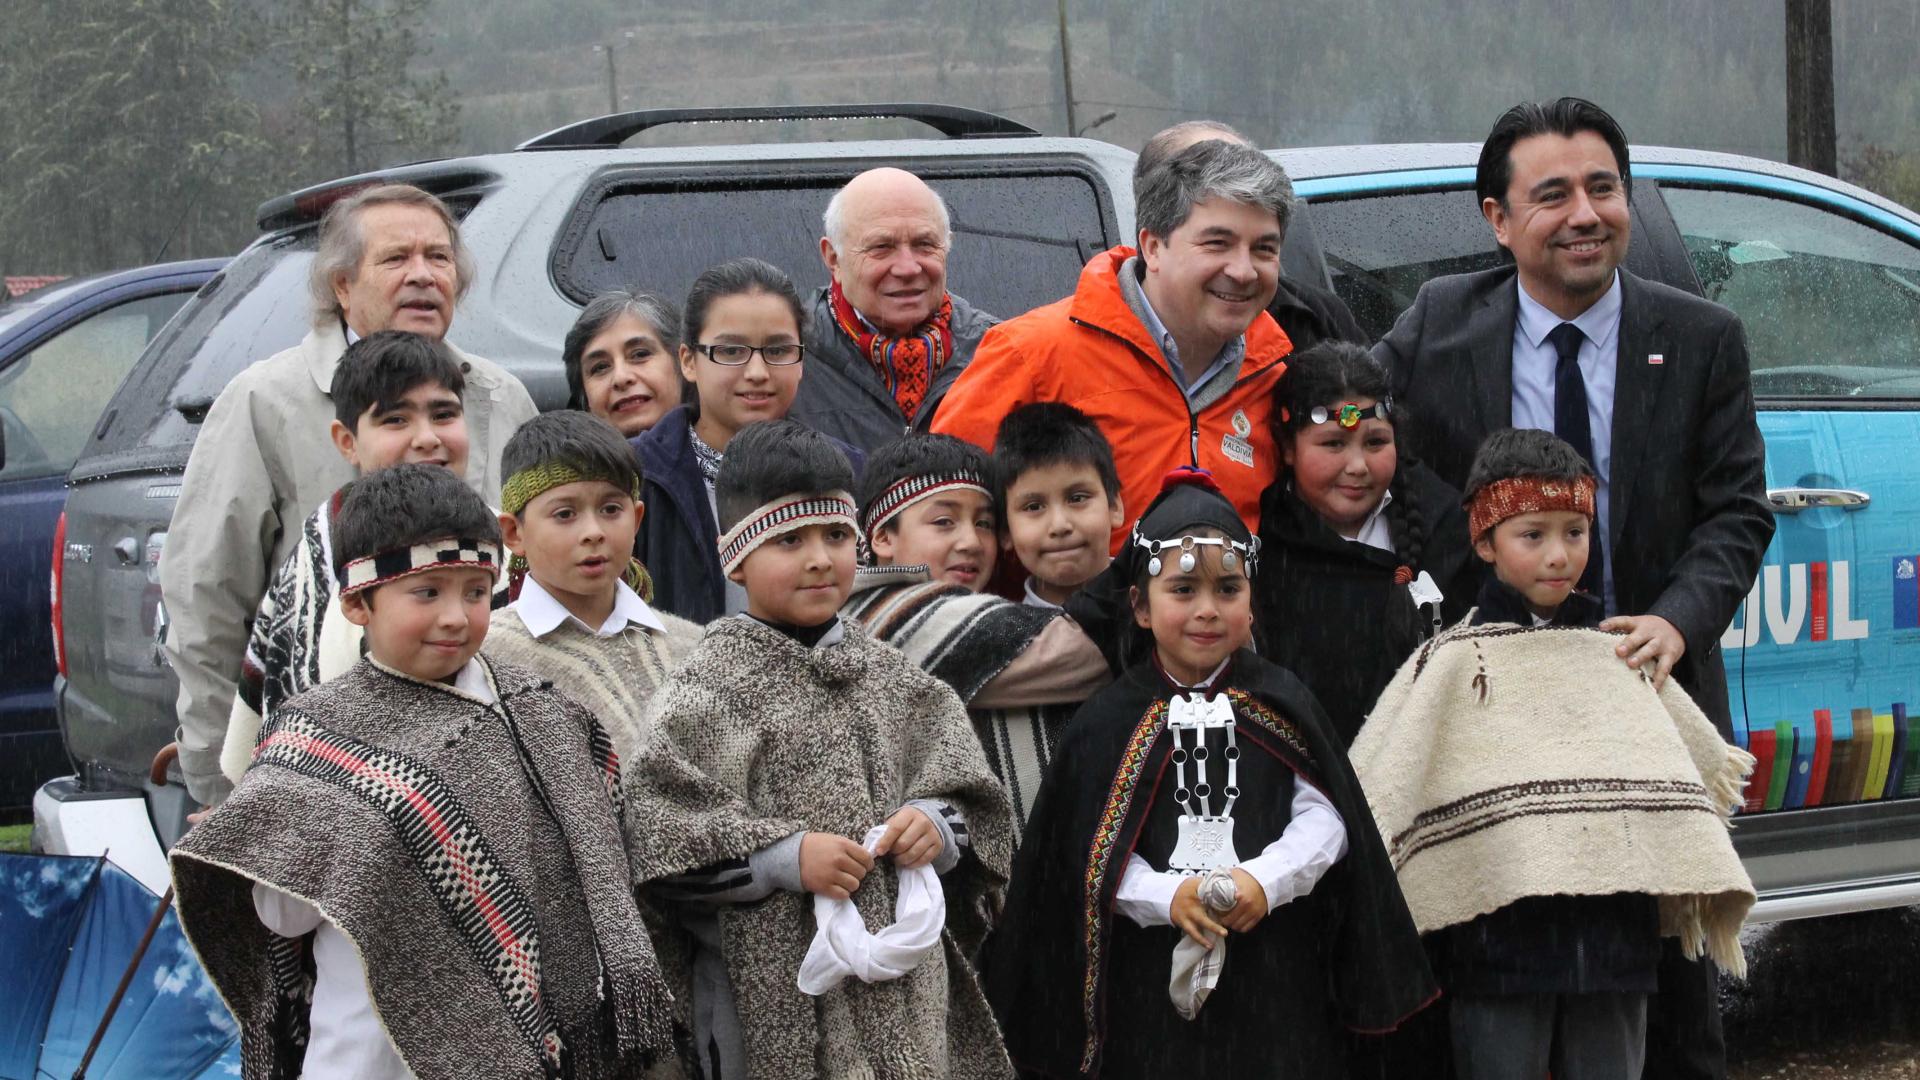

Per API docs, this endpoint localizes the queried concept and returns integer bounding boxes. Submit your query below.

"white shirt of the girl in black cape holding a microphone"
[1114,661,1346,926]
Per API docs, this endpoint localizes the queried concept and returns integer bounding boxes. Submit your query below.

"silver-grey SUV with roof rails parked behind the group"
[36,106,1133,880]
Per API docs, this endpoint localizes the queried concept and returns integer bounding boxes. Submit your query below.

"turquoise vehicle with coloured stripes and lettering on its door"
[1273,144,1920,920]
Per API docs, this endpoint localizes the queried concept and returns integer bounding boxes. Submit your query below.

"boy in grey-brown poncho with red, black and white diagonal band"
[173,465,672,1080]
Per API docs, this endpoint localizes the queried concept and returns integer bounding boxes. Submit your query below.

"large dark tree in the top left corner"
[0,0,265,273]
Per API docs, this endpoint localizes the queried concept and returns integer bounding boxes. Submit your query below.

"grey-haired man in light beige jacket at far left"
[159,184,536,805]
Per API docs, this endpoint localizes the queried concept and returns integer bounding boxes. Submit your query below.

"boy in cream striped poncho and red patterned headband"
[1352,430,1753,1080]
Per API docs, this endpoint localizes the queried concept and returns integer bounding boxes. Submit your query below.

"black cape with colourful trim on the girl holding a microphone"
[983,650,1438,1080]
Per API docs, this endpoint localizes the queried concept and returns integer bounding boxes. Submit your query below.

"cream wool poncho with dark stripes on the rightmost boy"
[1352,615,1755,978]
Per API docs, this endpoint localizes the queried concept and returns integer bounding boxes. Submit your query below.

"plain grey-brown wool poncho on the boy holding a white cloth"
[626,615,1014,1080]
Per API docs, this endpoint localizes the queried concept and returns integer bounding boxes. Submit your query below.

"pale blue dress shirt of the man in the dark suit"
[1513,271,1620,615]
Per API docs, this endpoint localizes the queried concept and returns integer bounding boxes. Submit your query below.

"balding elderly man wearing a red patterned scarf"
[787,169,998,452]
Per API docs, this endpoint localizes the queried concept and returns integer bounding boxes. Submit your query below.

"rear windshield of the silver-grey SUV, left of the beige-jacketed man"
[88,237,317,455]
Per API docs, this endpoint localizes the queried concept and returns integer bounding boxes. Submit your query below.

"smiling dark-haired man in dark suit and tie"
[1375,98,1774,1080]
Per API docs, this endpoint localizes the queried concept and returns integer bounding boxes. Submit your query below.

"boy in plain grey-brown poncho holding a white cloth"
[628,421,1014,1080]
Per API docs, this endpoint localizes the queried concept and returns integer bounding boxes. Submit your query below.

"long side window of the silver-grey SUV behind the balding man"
[553,161,1117,319]
